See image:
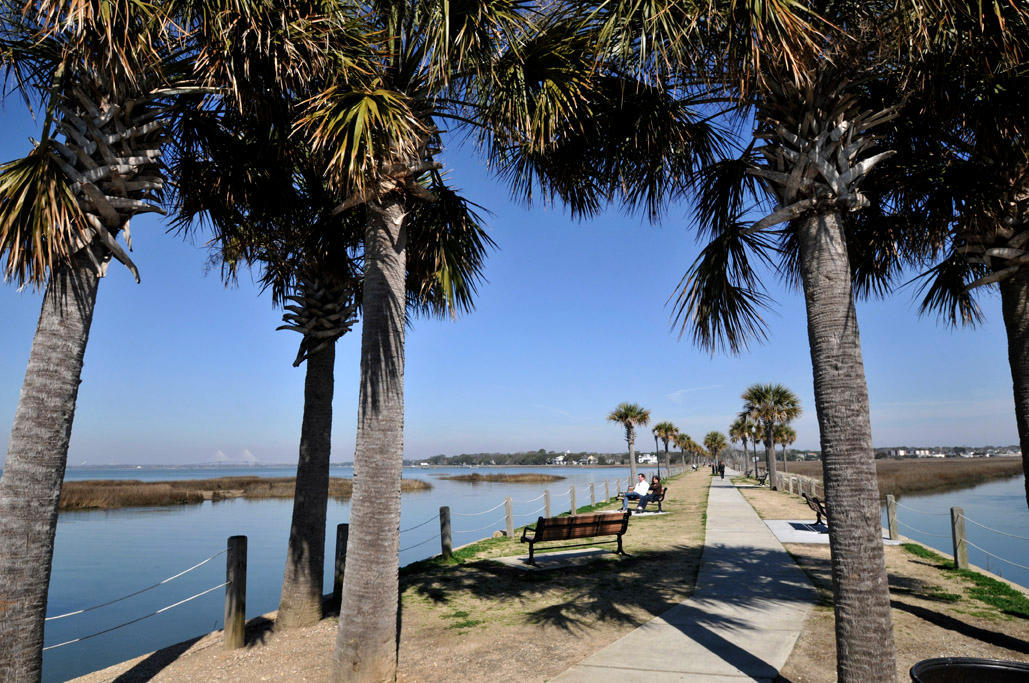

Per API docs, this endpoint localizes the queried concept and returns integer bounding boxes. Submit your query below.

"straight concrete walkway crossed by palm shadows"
[554,471,817,683]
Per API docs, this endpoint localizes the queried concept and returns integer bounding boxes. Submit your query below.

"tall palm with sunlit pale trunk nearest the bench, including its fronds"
[300,5,710,680]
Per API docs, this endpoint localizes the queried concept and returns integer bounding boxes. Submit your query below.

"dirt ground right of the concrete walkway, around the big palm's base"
[741,489,1029,683]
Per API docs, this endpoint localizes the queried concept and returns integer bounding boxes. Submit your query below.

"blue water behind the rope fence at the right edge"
[883,476,1029,587]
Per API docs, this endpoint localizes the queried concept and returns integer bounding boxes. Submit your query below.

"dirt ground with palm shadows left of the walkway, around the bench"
[76,470,710,683]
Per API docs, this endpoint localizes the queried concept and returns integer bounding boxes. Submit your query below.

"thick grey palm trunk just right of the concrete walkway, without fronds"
[794,214,896,683]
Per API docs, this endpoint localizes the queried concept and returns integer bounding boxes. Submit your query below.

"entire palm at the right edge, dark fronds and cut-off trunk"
[921,5,1029,504]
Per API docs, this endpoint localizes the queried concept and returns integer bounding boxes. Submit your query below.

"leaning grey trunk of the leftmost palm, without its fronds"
[0,255,99,681]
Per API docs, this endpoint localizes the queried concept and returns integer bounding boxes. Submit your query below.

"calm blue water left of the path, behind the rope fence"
[43,467,642,681]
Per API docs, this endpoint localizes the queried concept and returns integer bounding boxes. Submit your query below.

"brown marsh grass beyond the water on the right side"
[789,458,1022,500]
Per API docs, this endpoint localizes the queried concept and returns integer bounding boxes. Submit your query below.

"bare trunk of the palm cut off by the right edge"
[1000,271,1029,504]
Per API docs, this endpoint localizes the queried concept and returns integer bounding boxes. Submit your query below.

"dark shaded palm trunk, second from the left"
[275,342,335,628]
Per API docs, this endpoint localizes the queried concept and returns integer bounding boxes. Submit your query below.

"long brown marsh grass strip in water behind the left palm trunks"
[61,476,432,510]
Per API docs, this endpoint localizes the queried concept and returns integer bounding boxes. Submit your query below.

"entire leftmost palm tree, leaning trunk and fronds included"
[0,1,193,680]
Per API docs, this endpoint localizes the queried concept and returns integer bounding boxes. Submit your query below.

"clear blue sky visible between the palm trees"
[0,98,1018,465]
